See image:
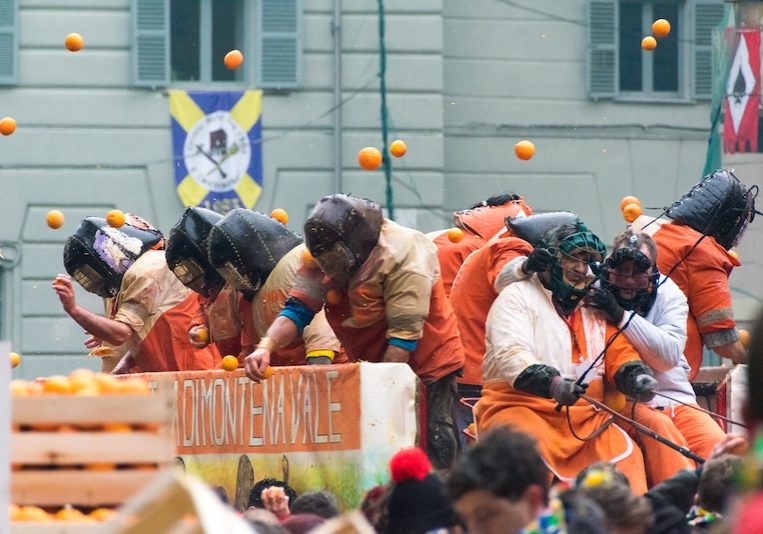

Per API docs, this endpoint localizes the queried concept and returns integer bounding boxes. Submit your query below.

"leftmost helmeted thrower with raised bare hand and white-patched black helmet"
[53,214,220,373]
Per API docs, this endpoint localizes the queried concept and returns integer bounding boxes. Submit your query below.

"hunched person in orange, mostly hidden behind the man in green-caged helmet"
[427,193,532,297]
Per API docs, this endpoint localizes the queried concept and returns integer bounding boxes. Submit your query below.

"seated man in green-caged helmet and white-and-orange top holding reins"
[474,222,656,494]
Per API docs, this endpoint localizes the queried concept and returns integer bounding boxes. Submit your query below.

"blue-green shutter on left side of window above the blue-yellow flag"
[132,0,170,87]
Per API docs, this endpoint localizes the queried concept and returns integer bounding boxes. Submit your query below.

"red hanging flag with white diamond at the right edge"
[723,29,760,154]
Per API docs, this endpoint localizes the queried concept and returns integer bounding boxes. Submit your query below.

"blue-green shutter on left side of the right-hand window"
[587,0,618,100]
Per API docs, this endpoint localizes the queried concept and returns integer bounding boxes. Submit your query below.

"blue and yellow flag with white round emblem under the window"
[169,90,262,214]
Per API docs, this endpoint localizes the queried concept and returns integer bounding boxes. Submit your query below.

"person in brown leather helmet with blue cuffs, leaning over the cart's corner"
[245,194,464,469]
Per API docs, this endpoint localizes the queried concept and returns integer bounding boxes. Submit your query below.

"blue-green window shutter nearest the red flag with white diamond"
[692,0,723,99]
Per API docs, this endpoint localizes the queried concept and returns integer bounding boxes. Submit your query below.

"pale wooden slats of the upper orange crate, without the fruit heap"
[10,388,175,510]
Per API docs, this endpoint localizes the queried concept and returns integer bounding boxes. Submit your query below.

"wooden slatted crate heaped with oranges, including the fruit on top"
[10,370,175,516]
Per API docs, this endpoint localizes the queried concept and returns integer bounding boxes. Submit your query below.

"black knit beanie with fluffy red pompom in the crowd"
[387,448,456,534]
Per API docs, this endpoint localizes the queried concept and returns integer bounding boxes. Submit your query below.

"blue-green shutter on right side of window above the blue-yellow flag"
[257,0,303,89]
